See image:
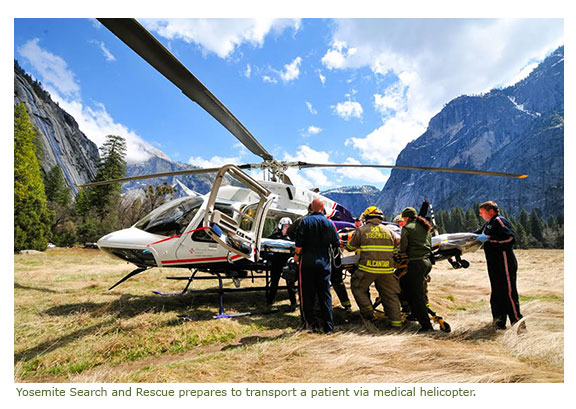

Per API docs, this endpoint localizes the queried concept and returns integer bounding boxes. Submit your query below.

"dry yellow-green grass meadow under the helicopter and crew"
[14,245,564,383]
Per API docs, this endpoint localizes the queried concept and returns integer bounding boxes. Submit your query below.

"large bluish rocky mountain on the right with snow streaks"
[378,47,564,215]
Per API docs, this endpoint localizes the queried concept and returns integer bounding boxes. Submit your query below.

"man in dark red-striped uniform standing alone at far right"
[474,201,522,329]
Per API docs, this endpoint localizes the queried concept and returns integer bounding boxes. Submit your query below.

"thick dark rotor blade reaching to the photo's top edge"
[98,18,272,160]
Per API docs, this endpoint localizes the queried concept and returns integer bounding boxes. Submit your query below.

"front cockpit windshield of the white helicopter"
[134,197,203,236]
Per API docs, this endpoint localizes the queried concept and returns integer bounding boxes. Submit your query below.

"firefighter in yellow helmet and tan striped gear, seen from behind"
[347,206,402,328]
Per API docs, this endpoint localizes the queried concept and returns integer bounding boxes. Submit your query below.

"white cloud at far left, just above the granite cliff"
[18,38,80,97]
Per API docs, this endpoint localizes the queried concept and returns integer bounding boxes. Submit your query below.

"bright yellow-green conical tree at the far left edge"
[14,104,52,251]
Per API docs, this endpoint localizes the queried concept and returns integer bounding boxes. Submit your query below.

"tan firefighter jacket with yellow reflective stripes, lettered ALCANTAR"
[347,219,398,274]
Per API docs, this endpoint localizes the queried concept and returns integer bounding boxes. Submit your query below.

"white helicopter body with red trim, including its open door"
[97,165,337,268]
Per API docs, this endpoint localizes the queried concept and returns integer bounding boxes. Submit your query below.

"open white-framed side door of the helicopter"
[204,165,274,261]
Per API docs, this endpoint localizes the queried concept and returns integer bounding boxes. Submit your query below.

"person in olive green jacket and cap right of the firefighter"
[399,207,433,331]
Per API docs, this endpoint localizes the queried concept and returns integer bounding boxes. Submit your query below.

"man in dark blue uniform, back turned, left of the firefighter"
[294,199,340,333]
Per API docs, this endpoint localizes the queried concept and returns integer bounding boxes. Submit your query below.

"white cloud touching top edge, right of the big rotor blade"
[140,18,300,58]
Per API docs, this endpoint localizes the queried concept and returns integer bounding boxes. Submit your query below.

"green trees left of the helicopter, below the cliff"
[14,104,176,251]
